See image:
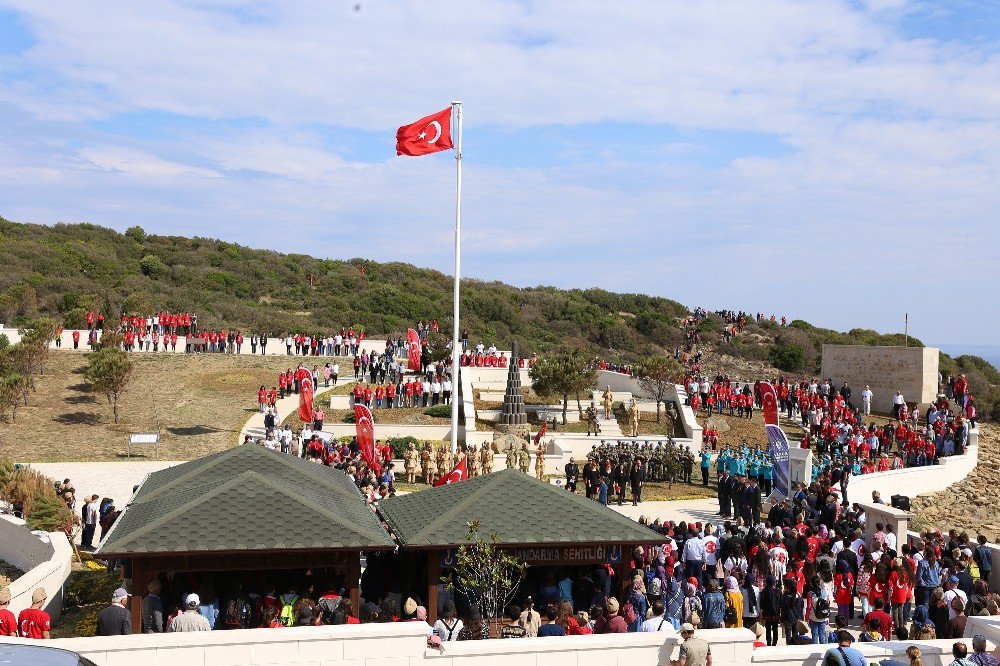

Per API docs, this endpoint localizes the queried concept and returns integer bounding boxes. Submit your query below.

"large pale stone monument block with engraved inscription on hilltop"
[822,345,939,414]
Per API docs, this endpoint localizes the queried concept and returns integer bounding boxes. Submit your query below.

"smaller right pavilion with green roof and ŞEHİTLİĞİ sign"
[378,469,656,622]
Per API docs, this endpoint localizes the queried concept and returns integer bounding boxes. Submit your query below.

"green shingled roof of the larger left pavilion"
[96,444,395,557]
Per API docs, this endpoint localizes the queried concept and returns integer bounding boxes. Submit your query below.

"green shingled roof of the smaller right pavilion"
[378,469,653,548]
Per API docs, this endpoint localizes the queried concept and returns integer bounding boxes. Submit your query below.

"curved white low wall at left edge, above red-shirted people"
[0,516,73,617]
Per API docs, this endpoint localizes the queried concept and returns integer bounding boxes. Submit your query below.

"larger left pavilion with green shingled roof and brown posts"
[95,444,395,633]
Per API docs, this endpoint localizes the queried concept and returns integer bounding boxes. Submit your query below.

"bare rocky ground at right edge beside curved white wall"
[912,426,1000,542]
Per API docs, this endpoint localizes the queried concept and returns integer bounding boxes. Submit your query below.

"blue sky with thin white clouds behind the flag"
[0,0,1000,344]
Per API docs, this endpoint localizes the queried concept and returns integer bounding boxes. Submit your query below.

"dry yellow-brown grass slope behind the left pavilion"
[0,352,312,462]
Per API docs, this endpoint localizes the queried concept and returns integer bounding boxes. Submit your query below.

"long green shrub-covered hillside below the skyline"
[0,218,1000,412]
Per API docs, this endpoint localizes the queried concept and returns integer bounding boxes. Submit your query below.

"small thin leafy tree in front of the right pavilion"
[441,521,528,619]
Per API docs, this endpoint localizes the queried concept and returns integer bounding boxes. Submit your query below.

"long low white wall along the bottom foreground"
[0,622,753,666]
